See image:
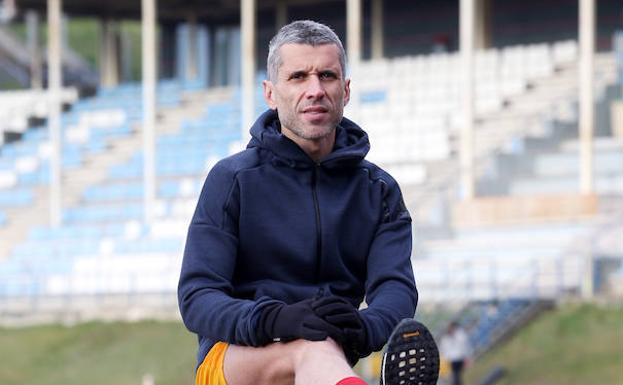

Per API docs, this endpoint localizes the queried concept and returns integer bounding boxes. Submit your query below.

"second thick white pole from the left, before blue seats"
[141,0,157,224]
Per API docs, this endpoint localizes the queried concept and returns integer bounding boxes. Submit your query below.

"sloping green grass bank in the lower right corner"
[466,304,623,385]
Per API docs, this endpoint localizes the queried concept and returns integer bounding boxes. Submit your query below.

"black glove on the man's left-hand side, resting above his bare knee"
[257,299,343,344]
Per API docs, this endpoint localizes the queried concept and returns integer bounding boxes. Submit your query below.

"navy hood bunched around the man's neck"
[247,109,370,168]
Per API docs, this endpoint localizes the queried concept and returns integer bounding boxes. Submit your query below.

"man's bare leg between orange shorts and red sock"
[223,339,364,385]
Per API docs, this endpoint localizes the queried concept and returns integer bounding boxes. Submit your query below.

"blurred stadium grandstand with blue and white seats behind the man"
[0,0,623,378]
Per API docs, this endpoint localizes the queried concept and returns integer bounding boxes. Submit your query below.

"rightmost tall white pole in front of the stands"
[579,0,595,194]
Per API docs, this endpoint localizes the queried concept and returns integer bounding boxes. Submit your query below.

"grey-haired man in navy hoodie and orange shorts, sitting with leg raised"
[179,21,438,385]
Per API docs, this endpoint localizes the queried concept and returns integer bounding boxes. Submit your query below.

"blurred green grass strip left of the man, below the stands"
[0,322,196,385]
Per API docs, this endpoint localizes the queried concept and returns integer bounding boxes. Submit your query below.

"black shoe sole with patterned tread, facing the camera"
[381,319,439,385]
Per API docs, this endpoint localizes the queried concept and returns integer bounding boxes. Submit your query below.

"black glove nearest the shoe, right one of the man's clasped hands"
[311,295,367,365]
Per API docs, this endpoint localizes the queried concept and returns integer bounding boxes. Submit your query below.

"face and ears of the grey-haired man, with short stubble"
[264,44,350,140]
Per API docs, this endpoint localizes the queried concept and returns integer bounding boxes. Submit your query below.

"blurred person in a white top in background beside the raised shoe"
[439,321,471,385]
